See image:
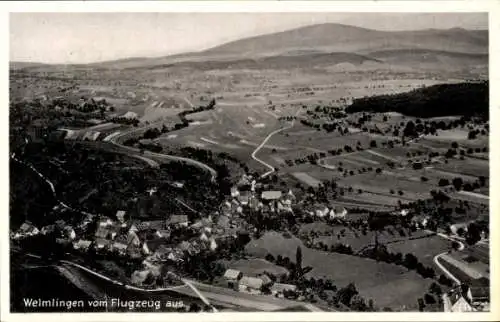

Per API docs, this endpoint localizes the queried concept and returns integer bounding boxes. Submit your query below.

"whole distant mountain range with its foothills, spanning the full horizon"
[11,23,488,70]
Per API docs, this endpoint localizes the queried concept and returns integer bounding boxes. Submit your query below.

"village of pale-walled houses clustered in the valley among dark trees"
[11,174,347,297]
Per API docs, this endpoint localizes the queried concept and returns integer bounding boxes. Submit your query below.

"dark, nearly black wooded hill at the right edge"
[346,81,489,118]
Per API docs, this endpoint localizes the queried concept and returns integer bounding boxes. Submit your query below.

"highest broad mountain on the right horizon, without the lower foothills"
[204,23,488,56]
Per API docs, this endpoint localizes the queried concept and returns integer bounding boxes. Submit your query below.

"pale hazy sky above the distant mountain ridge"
[10,13,488,63]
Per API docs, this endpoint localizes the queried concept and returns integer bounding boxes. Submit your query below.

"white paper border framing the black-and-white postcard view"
[0,0,500,322]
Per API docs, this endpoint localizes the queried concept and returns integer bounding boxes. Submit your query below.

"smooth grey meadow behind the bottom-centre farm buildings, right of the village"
[246,232,431,309]
